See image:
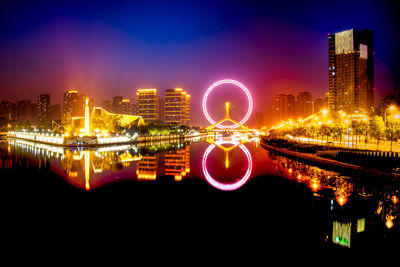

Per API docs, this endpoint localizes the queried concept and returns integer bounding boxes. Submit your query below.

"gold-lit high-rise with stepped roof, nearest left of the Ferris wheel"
[165,88,190,125]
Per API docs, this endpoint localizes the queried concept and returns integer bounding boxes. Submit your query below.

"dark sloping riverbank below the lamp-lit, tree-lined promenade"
[260,138,400,182]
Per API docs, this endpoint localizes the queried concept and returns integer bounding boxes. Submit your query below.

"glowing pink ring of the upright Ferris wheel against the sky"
[202,79,253,129]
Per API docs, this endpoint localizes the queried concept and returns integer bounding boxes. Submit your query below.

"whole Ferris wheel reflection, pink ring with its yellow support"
[202,138,253,191]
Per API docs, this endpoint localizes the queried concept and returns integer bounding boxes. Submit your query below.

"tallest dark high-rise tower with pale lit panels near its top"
[328,29,375,113]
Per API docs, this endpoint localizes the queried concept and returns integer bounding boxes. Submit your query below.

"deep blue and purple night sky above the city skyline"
[0,0,400,124]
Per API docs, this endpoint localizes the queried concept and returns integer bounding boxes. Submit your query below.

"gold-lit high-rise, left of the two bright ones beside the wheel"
[136,89,159,123]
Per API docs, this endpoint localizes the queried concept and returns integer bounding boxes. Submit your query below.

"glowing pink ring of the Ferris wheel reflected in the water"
[202,140,253,191]
